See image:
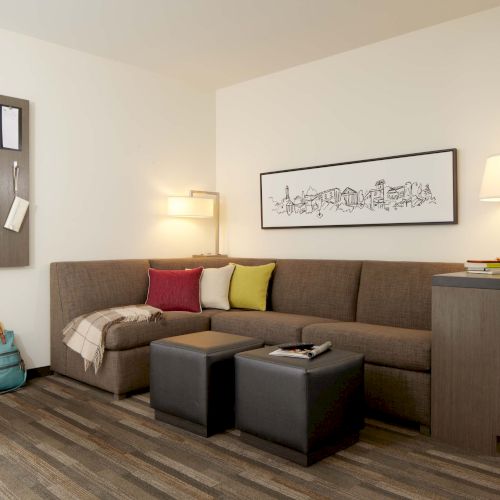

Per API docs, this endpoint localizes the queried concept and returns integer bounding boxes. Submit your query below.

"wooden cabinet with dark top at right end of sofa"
[431,272,500,455]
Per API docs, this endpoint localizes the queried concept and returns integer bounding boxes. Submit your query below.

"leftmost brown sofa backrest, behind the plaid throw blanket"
[51,259,149,326]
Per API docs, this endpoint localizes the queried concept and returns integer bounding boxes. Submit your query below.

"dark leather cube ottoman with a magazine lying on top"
[235,347,364,466]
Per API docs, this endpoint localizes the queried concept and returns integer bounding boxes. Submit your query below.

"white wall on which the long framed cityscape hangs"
[216,9,500,261]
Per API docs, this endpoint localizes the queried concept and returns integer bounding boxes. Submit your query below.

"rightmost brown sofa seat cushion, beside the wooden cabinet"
[302,322,431,371]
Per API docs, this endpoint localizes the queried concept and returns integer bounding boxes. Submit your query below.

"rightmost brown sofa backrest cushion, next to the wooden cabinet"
[356,261,464,330]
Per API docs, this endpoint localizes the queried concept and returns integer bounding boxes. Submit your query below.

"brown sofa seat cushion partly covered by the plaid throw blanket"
[105,311,210,351]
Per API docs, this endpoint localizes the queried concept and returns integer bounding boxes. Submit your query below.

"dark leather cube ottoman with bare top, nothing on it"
[150,331,263,437]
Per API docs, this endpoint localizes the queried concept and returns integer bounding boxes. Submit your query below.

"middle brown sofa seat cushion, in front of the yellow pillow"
[212,311,335,344]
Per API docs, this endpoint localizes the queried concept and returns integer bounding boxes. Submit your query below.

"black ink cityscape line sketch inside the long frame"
[269,179,438,219]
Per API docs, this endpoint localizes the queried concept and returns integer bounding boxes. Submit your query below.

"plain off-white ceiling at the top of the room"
[0,0,500,89]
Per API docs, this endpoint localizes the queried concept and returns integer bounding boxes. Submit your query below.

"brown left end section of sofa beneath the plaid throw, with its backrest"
[50,259,216,397]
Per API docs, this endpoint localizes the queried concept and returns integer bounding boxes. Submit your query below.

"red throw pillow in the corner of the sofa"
[146,267,203,312]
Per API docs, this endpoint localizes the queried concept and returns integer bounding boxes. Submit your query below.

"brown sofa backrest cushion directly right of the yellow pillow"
[272,259,361,321]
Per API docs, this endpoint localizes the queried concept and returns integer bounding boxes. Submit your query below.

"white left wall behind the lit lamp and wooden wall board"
[0,31,215,367]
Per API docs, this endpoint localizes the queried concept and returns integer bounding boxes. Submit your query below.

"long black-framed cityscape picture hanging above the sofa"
[260,148,458,229]
